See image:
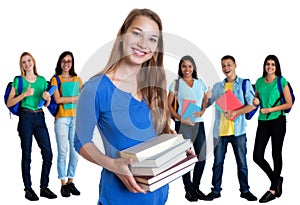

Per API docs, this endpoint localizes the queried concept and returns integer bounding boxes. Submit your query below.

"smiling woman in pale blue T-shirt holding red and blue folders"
[168,55,207,201]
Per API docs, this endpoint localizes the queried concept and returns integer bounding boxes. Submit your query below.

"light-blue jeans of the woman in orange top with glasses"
[54,117,78,179]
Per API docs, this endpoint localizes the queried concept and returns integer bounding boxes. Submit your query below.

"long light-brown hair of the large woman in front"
[98,9,170,134]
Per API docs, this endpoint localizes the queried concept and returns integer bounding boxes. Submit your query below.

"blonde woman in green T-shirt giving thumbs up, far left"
[7,52,57,201]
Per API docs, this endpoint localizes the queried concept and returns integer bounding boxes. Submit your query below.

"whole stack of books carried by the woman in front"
[120,134,198,192]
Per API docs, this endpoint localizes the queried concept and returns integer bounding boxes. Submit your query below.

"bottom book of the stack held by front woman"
[138,158,194,192]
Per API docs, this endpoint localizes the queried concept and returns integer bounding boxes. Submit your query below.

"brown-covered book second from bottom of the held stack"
[134,155,198,185]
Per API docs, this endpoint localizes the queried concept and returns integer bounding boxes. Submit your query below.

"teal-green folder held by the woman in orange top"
[61,82,79,110]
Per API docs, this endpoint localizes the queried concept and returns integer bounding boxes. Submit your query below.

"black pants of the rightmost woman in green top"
[253,116,286,190]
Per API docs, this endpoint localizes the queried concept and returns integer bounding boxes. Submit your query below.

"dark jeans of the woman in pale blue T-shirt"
[175,121,206,191]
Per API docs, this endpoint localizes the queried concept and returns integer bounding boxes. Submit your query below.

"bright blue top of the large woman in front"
[75,75,169,205]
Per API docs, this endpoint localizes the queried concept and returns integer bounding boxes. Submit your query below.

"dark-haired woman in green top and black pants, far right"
[253,55,292,203]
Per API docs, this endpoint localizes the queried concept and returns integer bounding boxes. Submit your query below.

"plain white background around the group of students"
[0,0,300,205]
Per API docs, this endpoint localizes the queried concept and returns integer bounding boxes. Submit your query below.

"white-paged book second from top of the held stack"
[131,139,192,167]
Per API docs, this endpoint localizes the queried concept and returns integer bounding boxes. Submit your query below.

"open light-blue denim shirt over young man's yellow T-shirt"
[208,77,254,138]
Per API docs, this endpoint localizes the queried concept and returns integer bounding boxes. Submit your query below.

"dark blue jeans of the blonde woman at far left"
[18,109,53,189]
